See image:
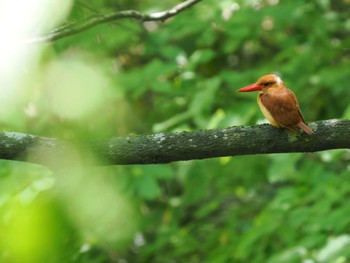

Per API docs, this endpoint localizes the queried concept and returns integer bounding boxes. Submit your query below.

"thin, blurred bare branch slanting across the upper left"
[25,0,202,43]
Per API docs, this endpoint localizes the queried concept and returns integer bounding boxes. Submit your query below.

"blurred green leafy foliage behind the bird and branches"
[0,0,350,263]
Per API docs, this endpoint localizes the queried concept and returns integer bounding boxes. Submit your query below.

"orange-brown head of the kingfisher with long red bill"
[237,74,284,93]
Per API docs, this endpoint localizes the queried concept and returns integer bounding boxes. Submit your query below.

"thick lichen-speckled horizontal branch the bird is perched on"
[0,120,350,167]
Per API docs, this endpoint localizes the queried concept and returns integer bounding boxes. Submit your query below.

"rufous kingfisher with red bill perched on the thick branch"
[237,74,314,135]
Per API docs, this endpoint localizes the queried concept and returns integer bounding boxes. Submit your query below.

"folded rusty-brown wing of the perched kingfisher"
[261,88,305,129]
